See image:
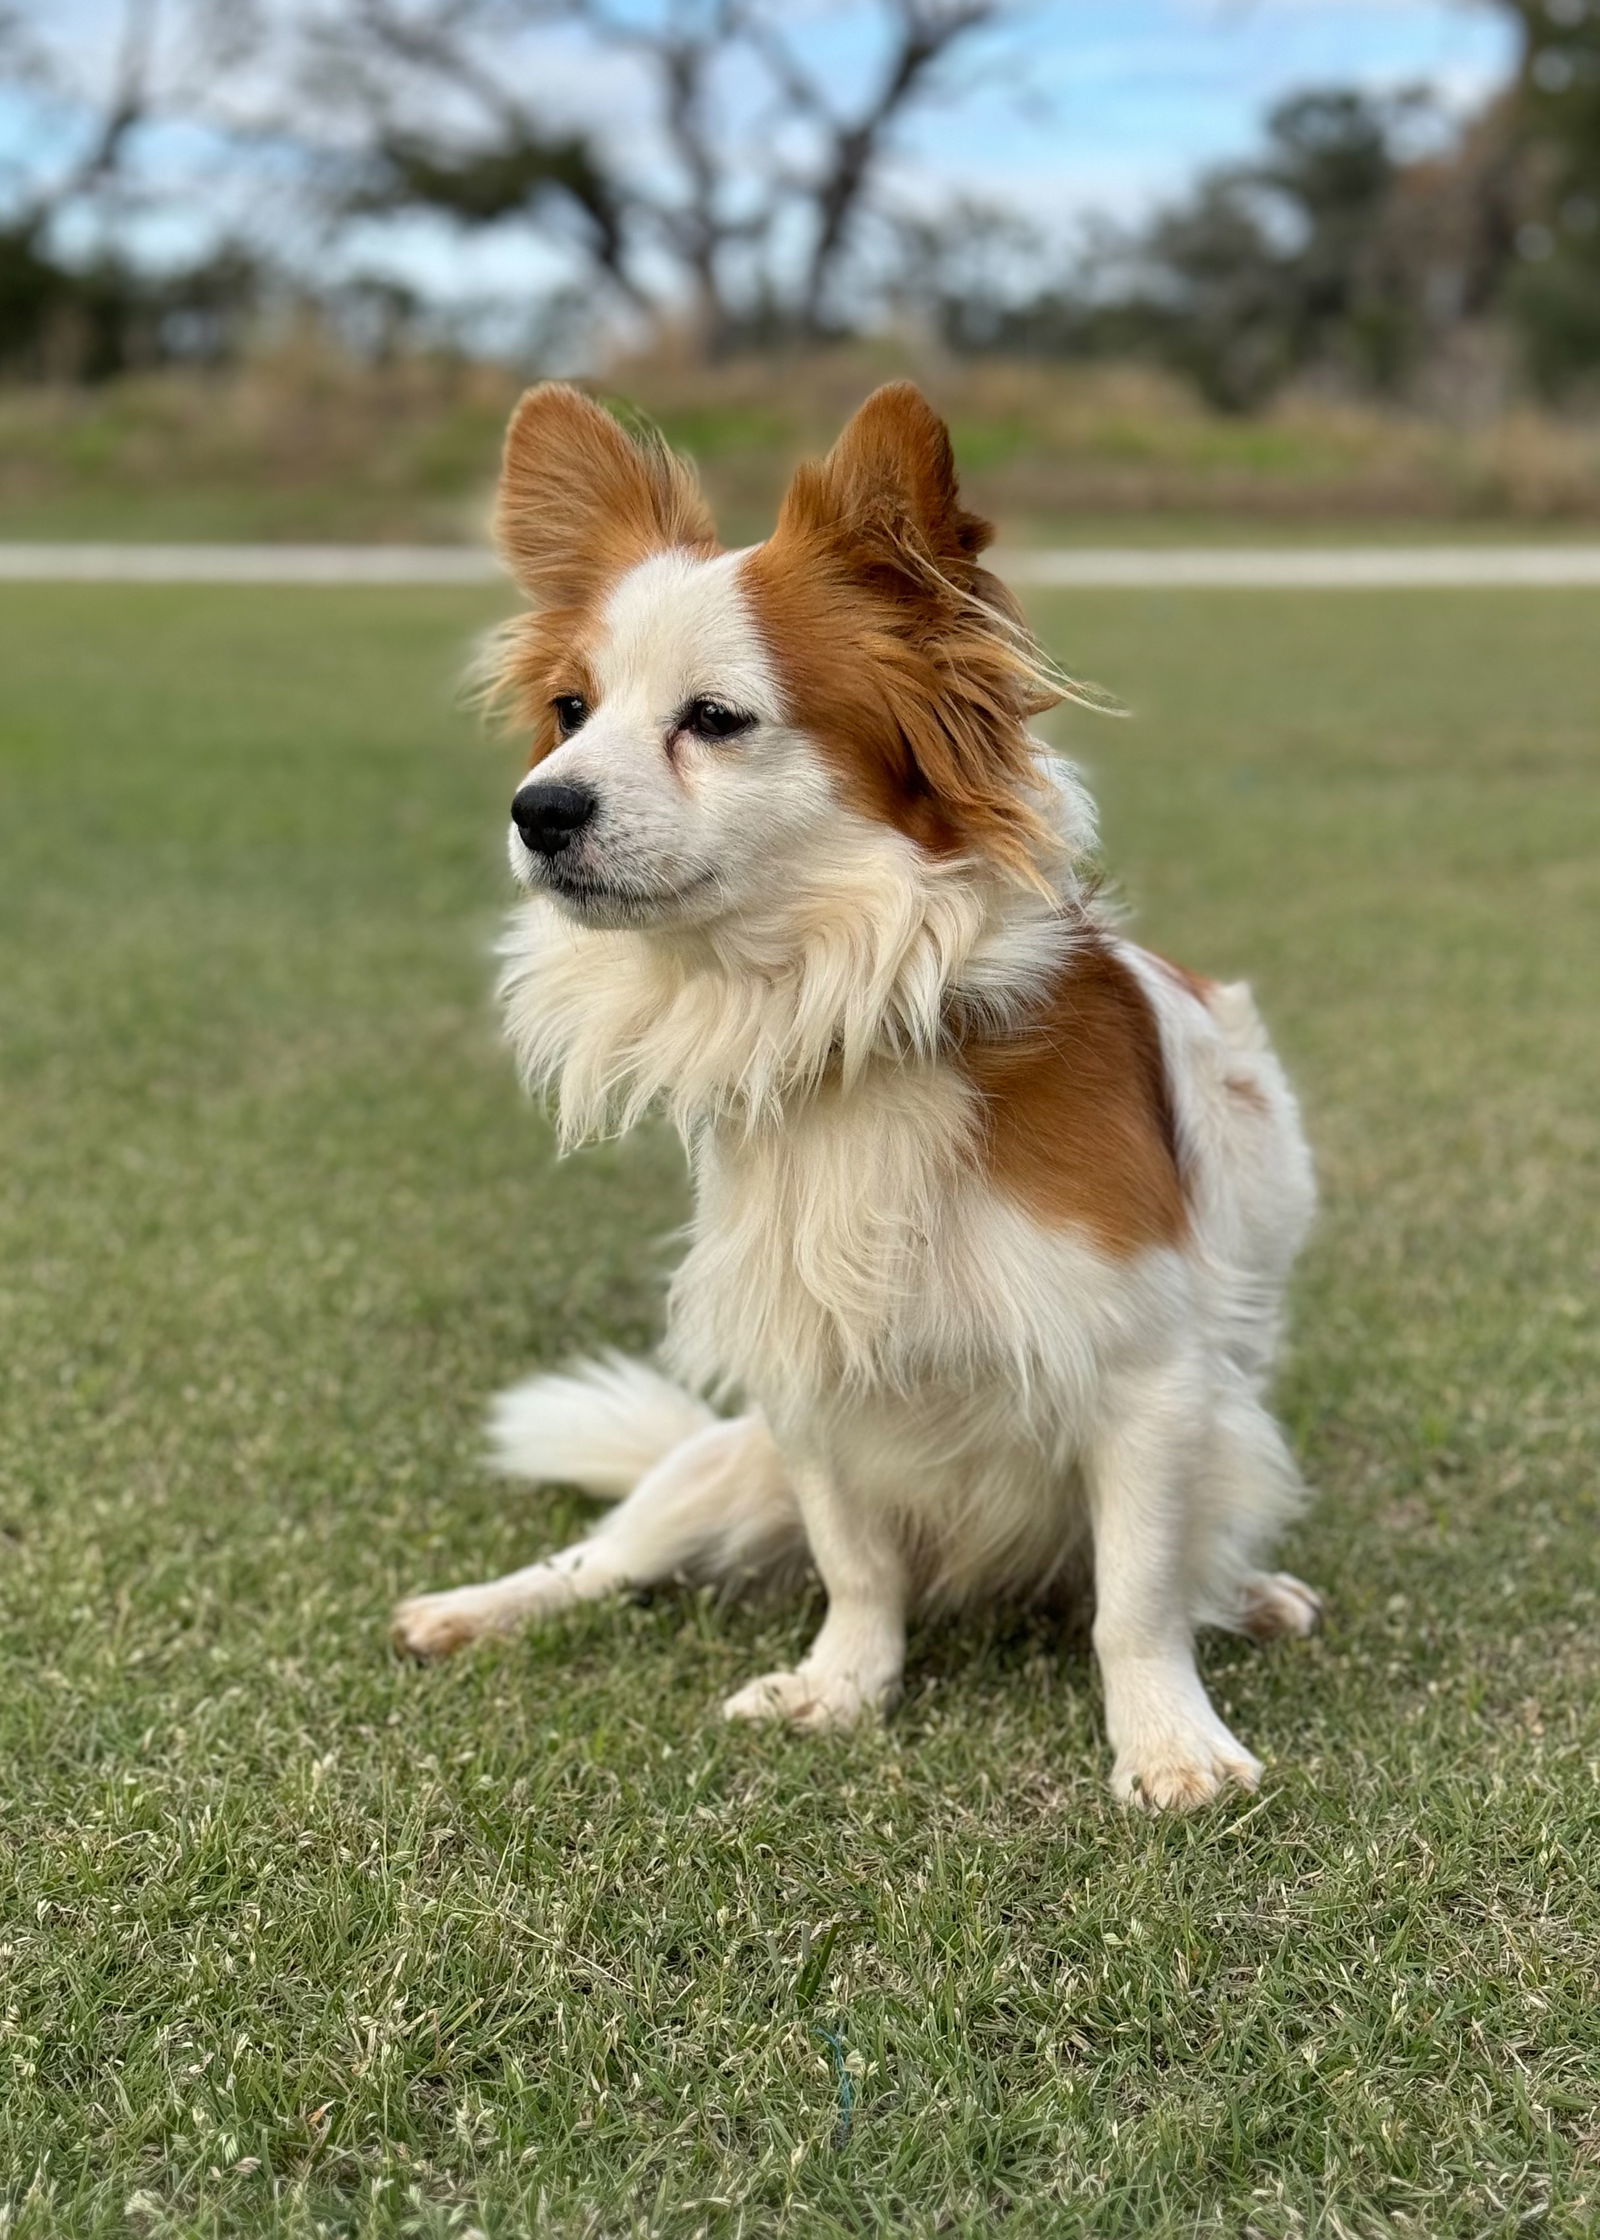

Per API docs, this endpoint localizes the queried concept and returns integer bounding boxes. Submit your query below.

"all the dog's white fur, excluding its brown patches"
[397,537,1315,1805]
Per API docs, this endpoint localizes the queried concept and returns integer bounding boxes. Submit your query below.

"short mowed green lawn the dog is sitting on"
[0,587,1600,2240]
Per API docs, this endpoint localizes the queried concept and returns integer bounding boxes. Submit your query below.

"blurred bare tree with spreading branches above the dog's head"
[289,0,1020,352]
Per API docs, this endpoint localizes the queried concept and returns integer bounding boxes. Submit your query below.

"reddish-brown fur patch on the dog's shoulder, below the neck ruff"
[964,941,1188,1259]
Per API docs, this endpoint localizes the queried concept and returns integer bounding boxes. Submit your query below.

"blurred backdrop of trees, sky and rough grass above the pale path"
[0,0,1600,540]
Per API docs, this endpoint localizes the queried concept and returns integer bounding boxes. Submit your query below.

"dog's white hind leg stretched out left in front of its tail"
[394,1416,804,1658]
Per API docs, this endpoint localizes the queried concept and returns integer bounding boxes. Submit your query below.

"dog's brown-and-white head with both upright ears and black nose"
[495,383,1060,930]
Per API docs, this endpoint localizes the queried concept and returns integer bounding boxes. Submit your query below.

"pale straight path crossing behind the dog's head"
[0,544,1600,591]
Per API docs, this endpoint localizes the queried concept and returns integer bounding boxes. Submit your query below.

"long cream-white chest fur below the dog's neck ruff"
[668,1064,1181,1447]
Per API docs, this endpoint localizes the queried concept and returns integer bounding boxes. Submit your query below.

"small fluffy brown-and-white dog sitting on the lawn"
[394,383,1318,1808]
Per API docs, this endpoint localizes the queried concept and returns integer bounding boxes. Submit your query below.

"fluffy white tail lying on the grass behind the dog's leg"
[489,1353,717,1501]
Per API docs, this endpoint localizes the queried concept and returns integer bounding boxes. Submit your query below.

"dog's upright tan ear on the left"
[495,381,717,607]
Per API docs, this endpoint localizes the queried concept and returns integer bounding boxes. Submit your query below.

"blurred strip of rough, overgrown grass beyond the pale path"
[0,336,1600,542]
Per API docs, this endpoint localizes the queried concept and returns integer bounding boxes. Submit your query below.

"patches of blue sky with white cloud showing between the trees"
[0,0,1510,309]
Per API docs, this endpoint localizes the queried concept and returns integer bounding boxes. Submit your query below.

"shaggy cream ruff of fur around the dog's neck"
[500,806,1091,1147]
